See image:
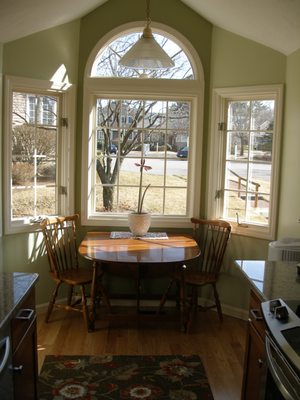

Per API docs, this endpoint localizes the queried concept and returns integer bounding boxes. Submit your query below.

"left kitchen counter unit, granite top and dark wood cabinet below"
[0,270,39,400]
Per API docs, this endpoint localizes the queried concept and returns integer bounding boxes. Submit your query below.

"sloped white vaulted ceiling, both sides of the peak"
[0,0,300,55]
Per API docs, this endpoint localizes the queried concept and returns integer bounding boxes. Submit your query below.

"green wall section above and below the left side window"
[0,20,80,303]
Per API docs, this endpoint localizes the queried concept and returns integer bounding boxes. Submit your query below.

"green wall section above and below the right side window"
[210,27,286,309]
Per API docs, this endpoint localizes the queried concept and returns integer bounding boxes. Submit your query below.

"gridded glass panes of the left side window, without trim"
[11,91,60,220]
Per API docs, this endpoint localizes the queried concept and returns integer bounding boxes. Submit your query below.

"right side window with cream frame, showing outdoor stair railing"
[212,86,282,239]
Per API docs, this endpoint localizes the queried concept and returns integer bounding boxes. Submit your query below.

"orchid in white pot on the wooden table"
[128,158,152,236]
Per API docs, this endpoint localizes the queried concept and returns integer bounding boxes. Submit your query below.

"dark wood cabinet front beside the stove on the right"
[241,290,266,400]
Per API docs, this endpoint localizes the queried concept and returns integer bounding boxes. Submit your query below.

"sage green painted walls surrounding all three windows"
[0,0,300,309]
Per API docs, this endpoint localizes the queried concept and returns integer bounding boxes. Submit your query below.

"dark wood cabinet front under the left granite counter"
[11,287,38,400]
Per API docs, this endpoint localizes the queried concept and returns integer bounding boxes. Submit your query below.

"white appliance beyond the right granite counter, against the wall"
[268,238,300,261]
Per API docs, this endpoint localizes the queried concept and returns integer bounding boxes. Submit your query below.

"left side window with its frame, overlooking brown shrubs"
[4,77,75,233]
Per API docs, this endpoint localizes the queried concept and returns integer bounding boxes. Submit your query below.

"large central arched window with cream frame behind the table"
[81,23,204,227]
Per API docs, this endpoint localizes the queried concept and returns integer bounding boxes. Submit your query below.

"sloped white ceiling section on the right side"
[181,0,300,55]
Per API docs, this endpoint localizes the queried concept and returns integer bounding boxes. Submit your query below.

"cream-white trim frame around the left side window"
[3,76,76,234]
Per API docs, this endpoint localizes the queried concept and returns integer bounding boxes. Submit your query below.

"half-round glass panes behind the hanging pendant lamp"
[91,32,195,79]
